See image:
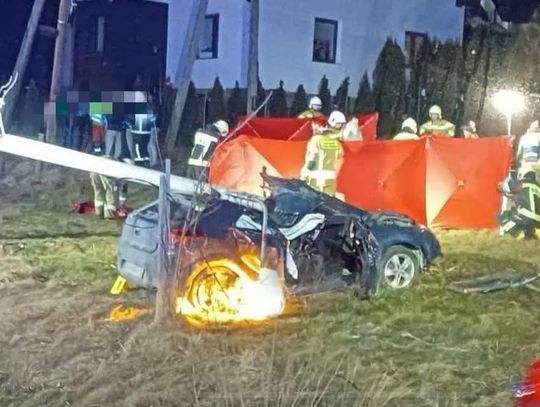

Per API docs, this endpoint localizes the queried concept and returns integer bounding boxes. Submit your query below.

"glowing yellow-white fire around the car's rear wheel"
[176,255,285,325]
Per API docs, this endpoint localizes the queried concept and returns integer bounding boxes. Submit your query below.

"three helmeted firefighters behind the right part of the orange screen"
[394,105,478,140]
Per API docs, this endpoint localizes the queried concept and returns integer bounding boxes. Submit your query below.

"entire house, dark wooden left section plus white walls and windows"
[67,0,464,93]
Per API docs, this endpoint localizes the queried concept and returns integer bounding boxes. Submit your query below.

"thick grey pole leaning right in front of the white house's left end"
[165,0,208,155]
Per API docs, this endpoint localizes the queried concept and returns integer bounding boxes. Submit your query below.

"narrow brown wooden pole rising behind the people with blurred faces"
[45,0,71,143]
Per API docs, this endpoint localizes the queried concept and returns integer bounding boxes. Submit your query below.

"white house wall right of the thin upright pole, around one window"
[259,0,463,93]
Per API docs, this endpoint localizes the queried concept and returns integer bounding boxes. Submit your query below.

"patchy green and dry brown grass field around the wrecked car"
[0,161,540,406]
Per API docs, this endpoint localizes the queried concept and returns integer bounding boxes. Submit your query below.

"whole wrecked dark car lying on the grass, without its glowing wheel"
[118,173,440,294]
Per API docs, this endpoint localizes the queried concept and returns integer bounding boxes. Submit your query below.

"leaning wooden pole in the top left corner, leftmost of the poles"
[3,0,45,128]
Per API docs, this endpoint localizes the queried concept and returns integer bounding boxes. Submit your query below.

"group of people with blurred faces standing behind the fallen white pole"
[90,91,159,219]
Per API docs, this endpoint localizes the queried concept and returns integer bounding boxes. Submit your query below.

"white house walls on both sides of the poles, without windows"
[154,0,463,94]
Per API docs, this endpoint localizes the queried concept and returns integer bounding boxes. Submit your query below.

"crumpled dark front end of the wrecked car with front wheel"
[262,172,441,288]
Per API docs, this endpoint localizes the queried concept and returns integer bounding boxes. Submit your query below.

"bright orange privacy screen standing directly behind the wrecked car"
[210,136,512,228]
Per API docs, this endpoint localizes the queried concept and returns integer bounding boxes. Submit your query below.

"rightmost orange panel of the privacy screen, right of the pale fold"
[426,137,512,228]
